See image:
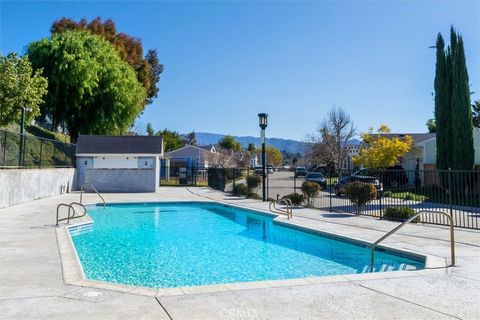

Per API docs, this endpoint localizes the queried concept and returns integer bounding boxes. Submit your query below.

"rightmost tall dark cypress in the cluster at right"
[451,35,475,170]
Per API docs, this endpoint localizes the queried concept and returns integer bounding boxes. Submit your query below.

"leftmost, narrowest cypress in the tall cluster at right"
[434,33,451,170]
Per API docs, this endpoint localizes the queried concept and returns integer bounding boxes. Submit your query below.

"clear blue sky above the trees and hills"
[0,0,480,139]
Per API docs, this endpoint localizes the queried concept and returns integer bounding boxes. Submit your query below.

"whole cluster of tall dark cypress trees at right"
[434,27,474,170]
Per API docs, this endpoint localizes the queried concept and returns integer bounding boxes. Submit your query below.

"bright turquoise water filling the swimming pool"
[70,202,424,288]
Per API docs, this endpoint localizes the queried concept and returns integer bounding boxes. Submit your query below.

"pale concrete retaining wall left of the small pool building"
[0,168,75,208]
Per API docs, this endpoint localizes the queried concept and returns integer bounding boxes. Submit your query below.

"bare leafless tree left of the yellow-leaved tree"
[309,106,356,169]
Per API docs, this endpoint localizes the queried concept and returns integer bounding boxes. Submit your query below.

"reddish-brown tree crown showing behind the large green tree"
[50,17,163,104]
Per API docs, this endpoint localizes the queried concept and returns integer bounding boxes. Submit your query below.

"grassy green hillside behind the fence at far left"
[0,125,75,167]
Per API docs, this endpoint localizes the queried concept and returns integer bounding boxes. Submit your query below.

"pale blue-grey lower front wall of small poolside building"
[78,168,159,192]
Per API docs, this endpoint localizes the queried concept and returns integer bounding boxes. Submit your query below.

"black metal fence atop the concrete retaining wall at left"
[0,130,75,168]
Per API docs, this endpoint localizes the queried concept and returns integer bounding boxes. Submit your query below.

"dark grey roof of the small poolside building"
[76,135,163,154]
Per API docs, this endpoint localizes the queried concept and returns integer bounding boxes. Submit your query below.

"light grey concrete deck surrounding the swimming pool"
[0,187,480,319]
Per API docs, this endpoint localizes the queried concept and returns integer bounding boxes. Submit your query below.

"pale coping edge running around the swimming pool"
[56,200,448,297]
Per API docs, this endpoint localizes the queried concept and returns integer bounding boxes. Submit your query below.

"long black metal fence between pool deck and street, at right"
[208,168,480,229]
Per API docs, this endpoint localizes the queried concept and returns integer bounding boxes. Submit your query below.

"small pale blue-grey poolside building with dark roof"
[76,135,164,192]
